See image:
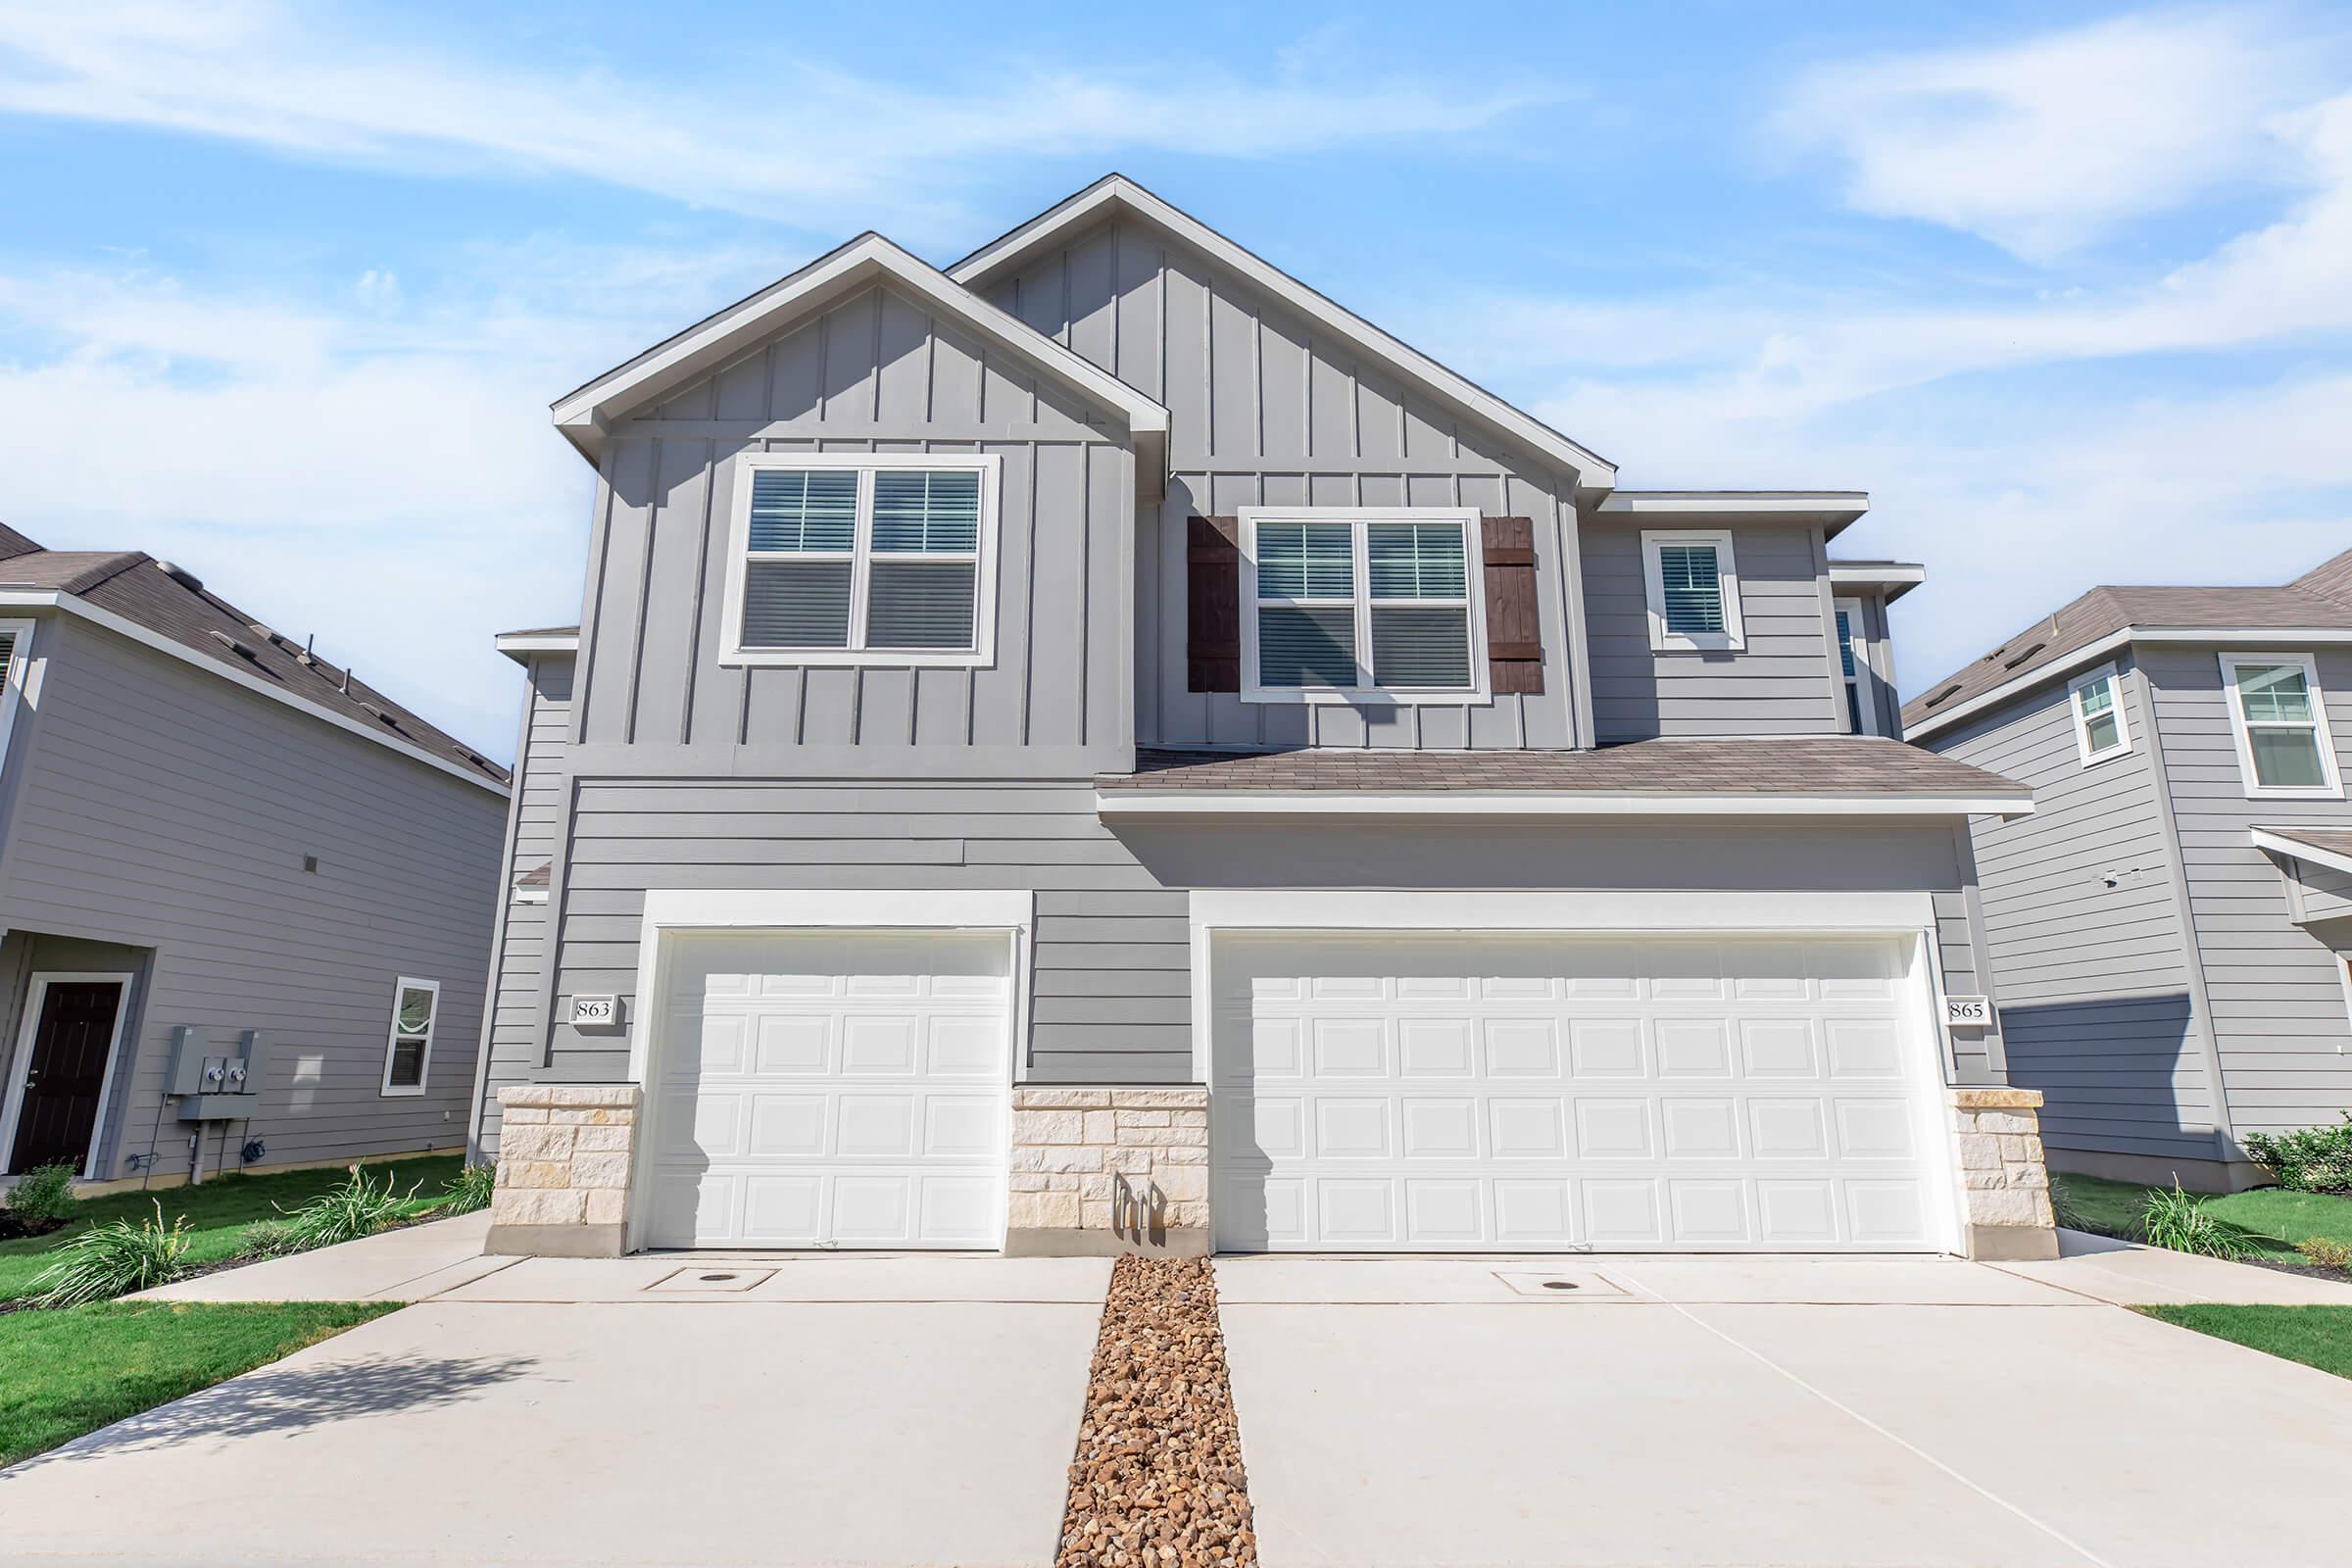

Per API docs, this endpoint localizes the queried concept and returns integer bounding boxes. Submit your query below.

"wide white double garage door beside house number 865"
[1211,936,1945,1250]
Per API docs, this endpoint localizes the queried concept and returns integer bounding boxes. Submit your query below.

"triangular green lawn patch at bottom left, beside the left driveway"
[0,1302,398,1464]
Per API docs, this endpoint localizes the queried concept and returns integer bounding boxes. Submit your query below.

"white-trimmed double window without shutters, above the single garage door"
[719,452,1000,665]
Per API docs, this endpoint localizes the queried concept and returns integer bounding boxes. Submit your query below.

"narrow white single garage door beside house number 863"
[647,931,1011,1249]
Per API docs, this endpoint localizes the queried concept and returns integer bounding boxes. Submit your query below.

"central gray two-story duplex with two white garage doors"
[480,176,2051,1253]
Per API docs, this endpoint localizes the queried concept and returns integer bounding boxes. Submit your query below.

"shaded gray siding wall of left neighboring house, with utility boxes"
[0,615,506,1175]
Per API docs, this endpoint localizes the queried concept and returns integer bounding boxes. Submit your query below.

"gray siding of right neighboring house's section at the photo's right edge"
[2140,639,2352,1133]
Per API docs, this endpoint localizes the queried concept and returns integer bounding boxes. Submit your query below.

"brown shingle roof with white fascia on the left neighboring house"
[0,526,508,792]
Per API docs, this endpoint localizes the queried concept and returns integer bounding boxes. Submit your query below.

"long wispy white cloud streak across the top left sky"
[0,0,1557,240]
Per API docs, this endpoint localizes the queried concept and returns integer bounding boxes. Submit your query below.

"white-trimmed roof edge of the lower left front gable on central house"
[553,230,1169,461]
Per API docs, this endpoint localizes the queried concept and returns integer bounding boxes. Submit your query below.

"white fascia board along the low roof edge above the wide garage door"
[1094,790,2034,815]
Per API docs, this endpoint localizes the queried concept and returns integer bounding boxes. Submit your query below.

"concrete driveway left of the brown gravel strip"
[0,1255,1110,1568]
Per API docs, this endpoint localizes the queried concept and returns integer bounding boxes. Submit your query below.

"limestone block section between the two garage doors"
[1004,1084,1209,1255]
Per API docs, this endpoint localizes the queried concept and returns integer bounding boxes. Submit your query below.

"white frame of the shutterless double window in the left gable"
[719,452,1004,670]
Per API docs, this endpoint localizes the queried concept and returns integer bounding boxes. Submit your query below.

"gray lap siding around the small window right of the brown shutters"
[1583,517,1846,743]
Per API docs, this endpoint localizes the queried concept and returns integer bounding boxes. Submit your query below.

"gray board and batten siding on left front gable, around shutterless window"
[571,287,1136,778]
